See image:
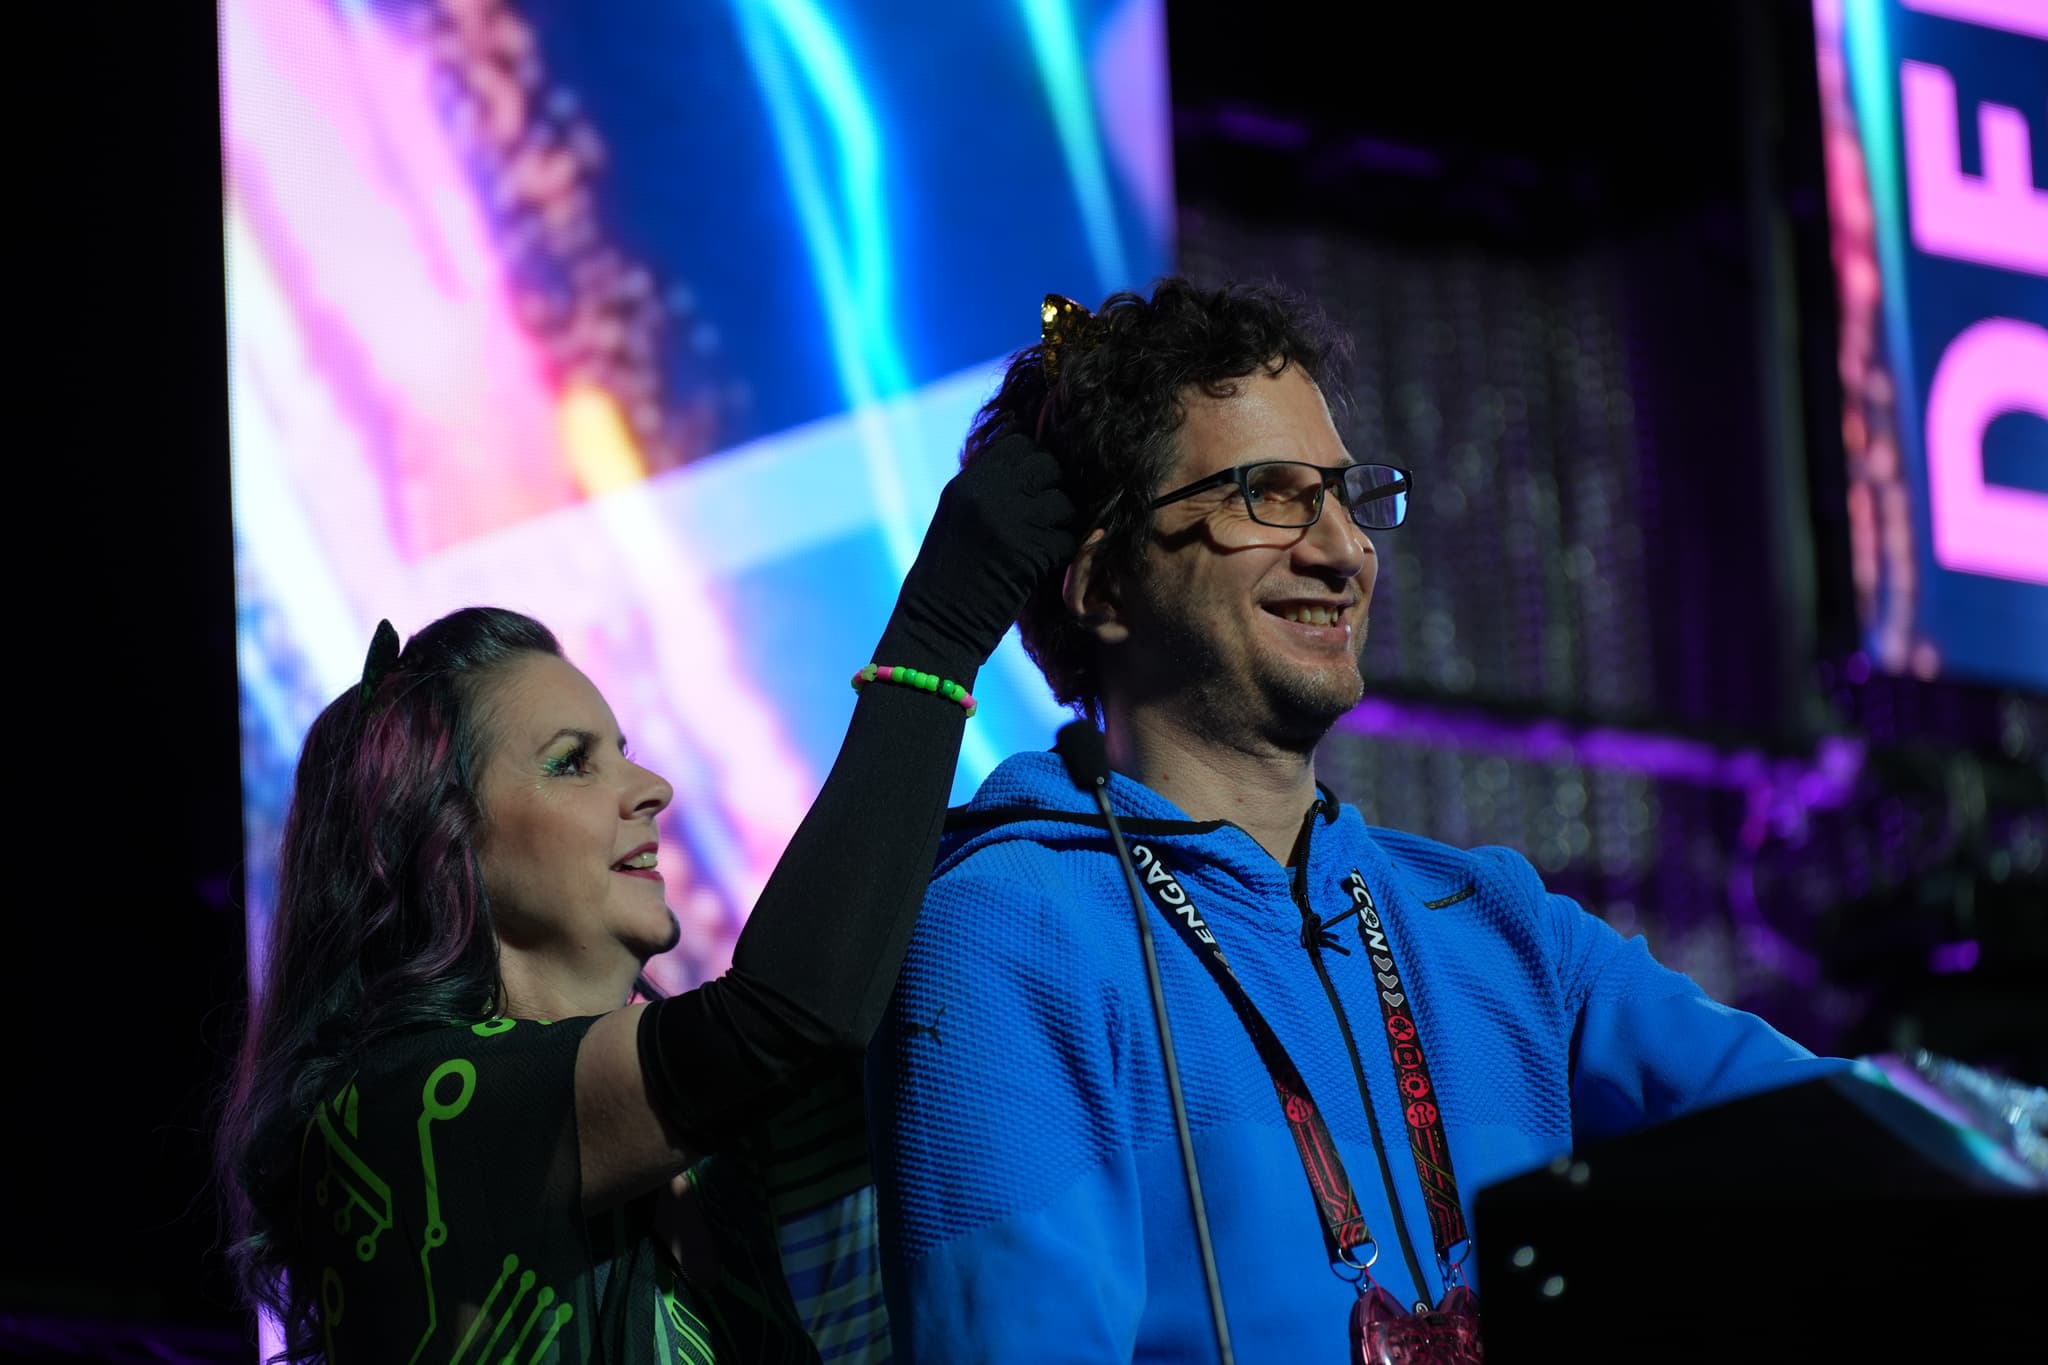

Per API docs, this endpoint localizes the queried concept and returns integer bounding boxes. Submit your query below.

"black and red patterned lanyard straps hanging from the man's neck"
[1130,843,1470,1281]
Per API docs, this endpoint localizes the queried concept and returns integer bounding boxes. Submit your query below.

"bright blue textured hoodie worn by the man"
[868,753,1847,1365]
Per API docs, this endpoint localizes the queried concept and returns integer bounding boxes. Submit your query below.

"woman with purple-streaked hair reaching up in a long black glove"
[217,438,1073,1365]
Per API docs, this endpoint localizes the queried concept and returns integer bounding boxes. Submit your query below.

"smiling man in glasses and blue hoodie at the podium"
[868,278,1843,1365]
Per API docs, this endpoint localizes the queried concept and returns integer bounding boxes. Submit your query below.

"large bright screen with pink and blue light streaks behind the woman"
[219,0,1171,988]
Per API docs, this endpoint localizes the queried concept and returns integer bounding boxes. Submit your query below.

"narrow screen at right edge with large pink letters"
[1815,0,2048,692]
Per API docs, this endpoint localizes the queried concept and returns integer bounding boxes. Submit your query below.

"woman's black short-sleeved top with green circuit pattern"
[299,1019,817,1365]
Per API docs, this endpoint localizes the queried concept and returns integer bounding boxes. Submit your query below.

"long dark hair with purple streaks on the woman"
[215,608,561,1361]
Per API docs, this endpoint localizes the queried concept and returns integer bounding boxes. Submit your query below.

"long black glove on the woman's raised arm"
[639,434,1075,1150]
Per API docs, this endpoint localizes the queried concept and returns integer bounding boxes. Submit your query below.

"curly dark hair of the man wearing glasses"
[961,276,1348,724]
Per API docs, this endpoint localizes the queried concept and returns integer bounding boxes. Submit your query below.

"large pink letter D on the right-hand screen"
[1927,317,2048,583]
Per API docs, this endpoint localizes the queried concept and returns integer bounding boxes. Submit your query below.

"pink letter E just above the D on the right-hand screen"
[1898,61,2048,274]
